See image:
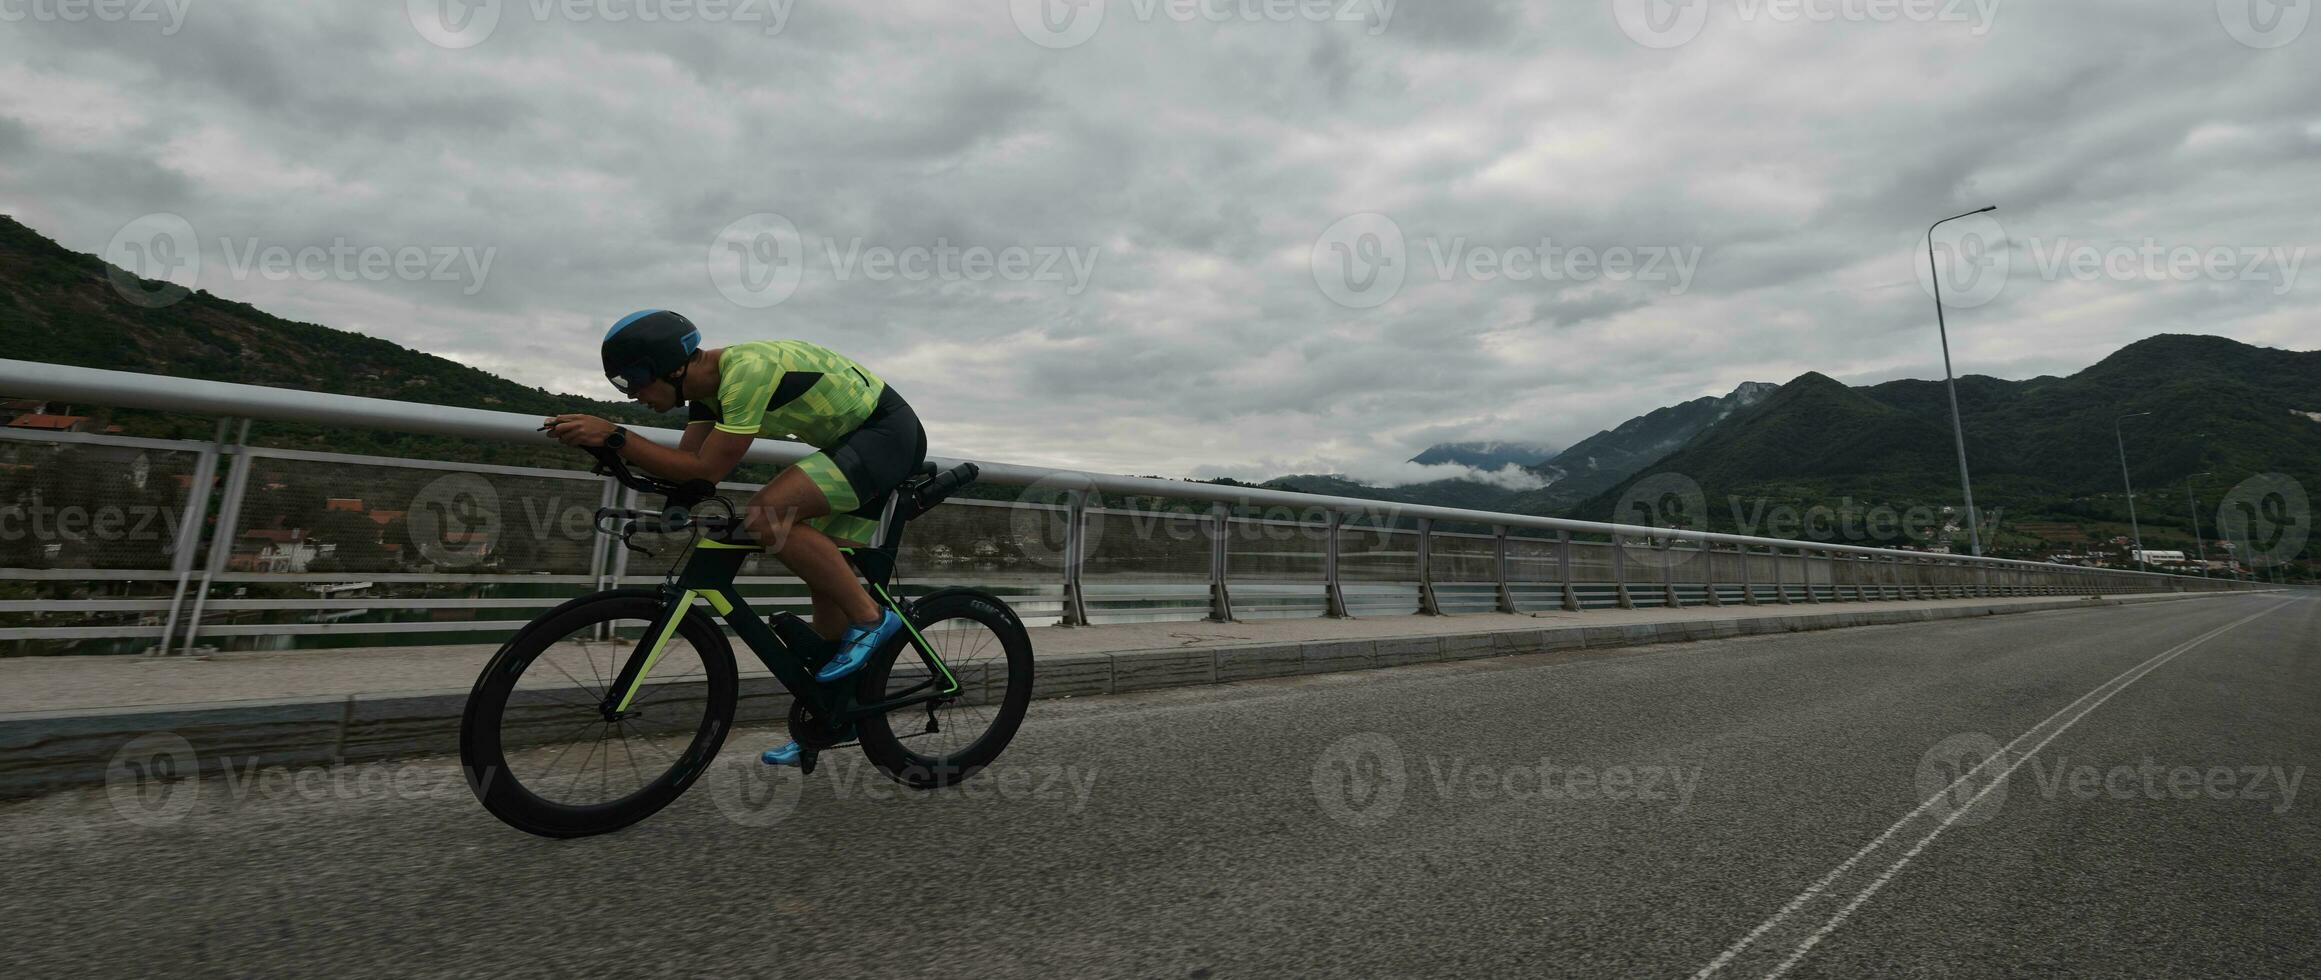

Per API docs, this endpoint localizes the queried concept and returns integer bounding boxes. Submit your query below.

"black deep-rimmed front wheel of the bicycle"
[460,592,738,836]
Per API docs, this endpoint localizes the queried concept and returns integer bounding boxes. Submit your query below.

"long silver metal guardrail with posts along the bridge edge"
[0,360,2242,650]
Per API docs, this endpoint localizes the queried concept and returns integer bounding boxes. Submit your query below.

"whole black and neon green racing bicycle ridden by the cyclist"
[460,448,1031,836]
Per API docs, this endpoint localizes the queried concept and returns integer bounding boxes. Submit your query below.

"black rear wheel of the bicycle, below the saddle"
[854,590,1031,790]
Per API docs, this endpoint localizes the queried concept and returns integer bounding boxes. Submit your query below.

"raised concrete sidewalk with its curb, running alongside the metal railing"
[0,592,2244,797]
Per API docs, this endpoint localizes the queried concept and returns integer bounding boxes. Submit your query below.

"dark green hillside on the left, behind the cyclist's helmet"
[0,216,675,467]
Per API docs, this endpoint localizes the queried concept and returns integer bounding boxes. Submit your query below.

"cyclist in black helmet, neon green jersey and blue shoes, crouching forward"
[545,309,926,766]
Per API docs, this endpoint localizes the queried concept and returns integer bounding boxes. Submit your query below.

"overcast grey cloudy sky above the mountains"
[0,0,2321,481]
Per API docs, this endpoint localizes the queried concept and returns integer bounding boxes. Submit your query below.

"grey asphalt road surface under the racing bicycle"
[0,597,2321,978]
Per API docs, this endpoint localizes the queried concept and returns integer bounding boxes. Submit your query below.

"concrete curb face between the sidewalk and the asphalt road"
[0,592,2242,799]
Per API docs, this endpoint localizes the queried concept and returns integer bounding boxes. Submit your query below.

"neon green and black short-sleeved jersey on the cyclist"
[689,341,887,448]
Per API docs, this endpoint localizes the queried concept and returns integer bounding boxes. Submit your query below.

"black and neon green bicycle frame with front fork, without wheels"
[599,536,961,727]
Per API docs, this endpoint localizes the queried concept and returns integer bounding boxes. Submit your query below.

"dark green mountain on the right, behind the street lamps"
[1571,334,2321,566]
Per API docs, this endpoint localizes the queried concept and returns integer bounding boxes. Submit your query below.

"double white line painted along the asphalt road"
[1692,601,2289,980]
